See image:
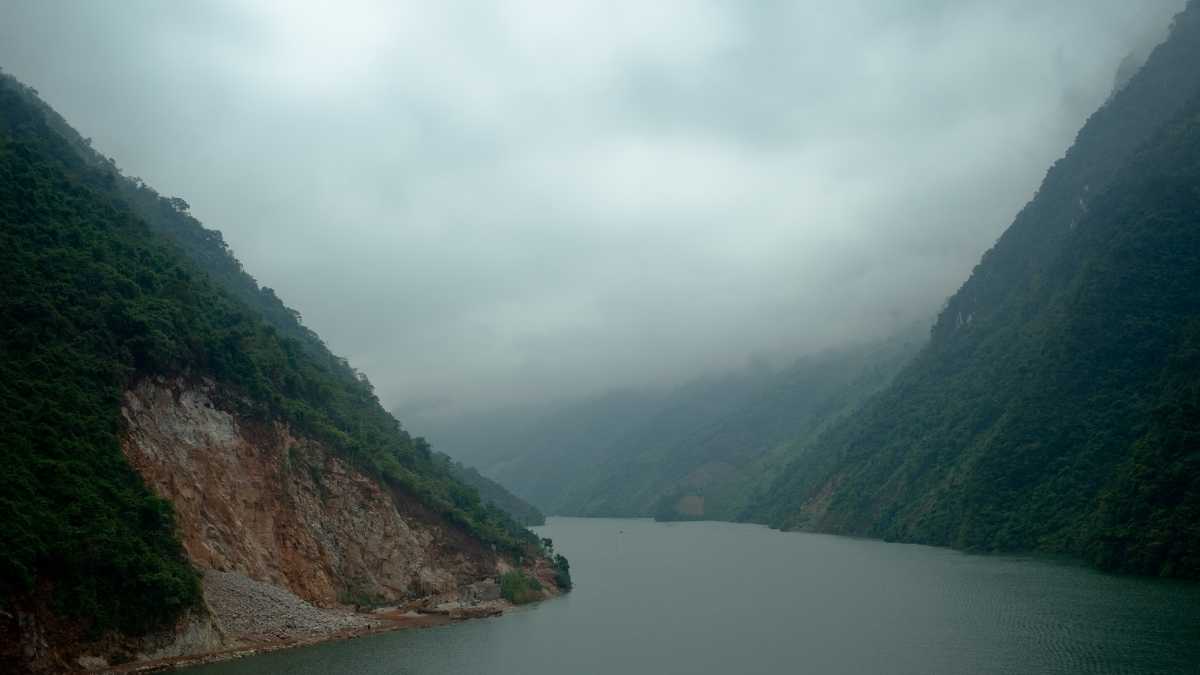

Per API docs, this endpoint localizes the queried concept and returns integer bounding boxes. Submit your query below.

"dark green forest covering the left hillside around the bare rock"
[0,73,549,632]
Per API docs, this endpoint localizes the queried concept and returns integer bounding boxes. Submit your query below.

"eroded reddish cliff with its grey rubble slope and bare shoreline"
[14,377,558,671]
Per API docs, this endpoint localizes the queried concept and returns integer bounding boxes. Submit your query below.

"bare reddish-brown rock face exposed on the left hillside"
[122,378,497,607]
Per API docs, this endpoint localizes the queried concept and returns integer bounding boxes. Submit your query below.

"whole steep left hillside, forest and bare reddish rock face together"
[0,74,553,670]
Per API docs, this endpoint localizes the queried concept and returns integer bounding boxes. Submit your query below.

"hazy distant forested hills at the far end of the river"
[427,325,928,520]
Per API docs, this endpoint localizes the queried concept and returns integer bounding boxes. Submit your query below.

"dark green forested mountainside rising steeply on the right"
[751,2,1200,577]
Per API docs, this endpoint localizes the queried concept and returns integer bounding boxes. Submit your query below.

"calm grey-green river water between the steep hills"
[184,518,1200,675]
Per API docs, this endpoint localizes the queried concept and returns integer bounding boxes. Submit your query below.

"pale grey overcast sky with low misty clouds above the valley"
[0,0,1182,413]
